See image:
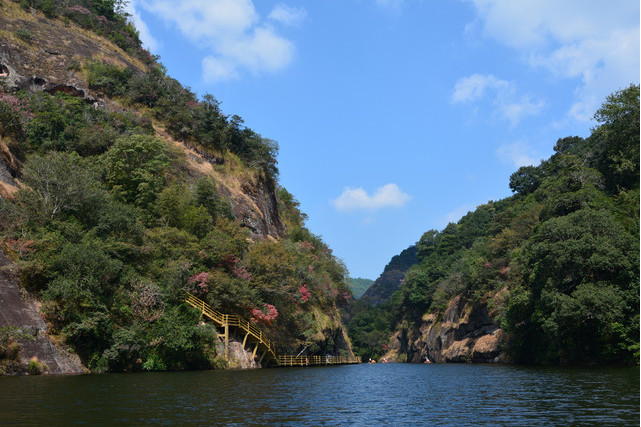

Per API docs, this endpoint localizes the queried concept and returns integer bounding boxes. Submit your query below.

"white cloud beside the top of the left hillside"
[140,0,305,82]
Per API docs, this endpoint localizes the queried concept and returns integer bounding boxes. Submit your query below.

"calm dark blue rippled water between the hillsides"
[0,364,639,426]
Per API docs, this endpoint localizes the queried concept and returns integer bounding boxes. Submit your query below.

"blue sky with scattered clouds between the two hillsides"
[124,0,640,279]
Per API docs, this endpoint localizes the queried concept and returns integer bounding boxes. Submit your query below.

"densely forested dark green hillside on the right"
[350,86,639,364]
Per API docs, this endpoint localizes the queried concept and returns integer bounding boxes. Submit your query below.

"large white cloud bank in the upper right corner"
[467,0,640,121]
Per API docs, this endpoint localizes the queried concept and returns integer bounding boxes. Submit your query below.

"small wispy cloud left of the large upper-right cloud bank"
[451,74,545,126]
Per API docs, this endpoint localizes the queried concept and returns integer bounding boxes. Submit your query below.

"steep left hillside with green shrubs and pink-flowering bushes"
[0,0,352,371]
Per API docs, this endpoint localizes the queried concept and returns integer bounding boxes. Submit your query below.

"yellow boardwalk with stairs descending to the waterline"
[185,292,361,366]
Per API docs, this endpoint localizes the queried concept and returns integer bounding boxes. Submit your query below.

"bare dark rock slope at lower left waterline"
[0,251,84,374]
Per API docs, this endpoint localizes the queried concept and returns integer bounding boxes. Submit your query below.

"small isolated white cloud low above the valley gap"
[331,184,412,212]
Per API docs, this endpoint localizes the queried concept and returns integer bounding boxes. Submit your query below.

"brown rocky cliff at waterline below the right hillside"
[385,296,507,363]
